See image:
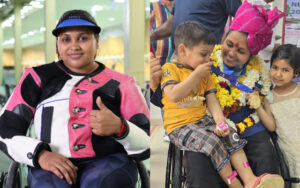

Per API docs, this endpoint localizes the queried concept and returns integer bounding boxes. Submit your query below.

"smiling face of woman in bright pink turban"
[222,31,251,67]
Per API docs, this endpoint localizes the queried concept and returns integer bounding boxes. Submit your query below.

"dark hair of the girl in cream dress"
[271,44,300,74]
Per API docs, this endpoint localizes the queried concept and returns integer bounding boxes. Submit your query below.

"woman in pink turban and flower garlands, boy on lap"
[166,1,284,188]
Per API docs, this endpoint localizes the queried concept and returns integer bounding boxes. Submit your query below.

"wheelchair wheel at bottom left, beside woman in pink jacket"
[6,162,21,188]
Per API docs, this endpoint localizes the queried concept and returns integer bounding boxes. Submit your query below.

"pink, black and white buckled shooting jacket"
[0,61,150,167]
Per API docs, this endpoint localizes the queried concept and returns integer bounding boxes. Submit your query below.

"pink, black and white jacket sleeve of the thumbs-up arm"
[116,78,150,159]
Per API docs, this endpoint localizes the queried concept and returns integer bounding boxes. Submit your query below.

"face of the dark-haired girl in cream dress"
[270,59,294,87]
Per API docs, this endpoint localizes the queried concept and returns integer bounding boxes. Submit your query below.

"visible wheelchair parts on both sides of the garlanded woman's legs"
[165,132,300,188]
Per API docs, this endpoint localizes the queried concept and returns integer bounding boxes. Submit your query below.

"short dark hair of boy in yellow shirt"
[174,21,216,54]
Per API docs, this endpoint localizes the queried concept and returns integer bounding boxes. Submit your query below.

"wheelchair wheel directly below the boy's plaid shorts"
[165,143,186,188]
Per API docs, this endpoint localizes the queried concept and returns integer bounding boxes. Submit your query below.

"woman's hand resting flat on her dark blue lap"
[38,150,78,185]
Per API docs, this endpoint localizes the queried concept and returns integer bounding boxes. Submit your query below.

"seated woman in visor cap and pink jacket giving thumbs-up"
[0,10,149,188]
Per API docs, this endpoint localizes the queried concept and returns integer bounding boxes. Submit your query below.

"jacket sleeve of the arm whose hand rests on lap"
[0,69,51,167]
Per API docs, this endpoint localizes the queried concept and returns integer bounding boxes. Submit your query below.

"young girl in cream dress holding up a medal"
[248,44,300,187]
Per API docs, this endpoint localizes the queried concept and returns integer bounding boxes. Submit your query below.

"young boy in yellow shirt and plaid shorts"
[161,21,283,188]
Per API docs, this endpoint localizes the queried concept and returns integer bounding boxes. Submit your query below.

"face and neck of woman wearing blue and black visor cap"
[57,27,99,74]
